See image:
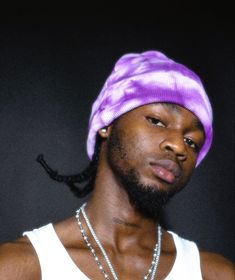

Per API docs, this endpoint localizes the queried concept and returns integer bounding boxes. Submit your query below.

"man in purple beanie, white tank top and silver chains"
[0,51,235,280]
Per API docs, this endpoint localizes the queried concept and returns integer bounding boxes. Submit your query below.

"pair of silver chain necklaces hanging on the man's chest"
[76,203,162,280]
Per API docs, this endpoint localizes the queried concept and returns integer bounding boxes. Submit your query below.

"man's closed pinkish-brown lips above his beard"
[150,159,182,184]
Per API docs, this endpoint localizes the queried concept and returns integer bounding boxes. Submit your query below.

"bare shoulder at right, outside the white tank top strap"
[200,250,235,280]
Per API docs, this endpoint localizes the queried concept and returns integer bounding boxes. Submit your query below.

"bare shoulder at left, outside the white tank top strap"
[0,237,41,280]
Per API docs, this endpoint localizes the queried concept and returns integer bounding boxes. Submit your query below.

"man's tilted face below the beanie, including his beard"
[104,103,204,219]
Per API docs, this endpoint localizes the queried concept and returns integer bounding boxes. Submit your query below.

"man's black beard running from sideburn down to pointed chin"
[107,124,179,221]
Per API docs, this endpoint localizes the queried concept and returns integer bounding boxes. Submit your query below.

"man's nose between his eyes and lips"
[160,133,187,161]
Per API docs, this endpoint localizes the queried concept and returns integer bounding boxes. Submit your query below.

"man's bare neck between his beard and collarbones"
[82,158,160,250]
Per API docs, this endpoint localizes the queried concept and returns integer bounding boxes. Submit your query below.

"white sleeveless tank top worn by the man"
[23,223,202,280]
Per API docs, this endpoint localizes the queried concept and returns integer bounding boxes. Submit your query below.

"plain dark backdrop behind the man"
[0,8,235,261]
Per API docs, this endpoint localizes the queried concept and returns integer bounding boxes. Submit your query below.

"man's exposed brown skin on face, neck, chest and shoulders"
[0,104,234,280]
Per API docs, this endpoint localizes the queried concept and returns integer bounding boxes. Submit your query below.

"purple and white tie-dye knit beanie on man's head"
[87,50,212,165]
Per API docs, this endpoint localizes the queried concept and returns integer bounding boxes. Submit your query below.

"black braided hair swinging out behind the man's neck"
[37,134,102,198]
